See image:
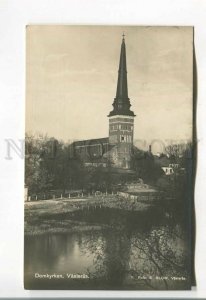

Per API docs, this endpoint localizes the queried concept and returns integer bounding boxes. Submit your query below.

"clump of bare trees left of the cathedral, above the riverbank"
[25,134,87,194]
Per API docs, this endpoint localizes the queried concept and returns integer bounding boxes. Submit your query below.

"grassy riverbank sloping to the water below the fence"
[25,195,152,235]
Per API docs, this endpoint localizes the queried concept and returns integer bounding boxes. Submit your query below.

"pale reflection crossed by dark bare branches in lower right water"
[130,226,189,289]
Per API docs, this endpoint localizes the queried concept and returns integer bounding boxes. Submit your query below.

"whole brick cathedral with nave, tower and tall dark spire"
[72,34,135,171]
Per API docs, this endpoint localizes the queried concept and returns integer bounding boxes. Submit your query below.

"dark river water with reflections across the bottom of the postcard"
[25,210,190,289]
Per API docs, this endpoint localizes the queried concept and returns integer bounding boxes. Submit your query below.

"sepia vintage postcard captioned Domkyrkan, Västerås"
[24,25,194,290]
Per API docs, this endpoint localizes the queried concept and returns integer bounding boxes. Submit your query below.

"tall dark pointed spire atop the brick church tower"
[109,34,135,117]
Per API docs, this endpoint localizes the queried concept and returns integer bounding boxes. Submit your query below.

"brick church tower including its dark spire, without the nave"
[108,34,135,169]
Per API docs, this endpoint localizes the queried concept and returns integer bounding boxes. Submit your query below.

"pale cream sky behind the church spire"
[26,25,193,149]
